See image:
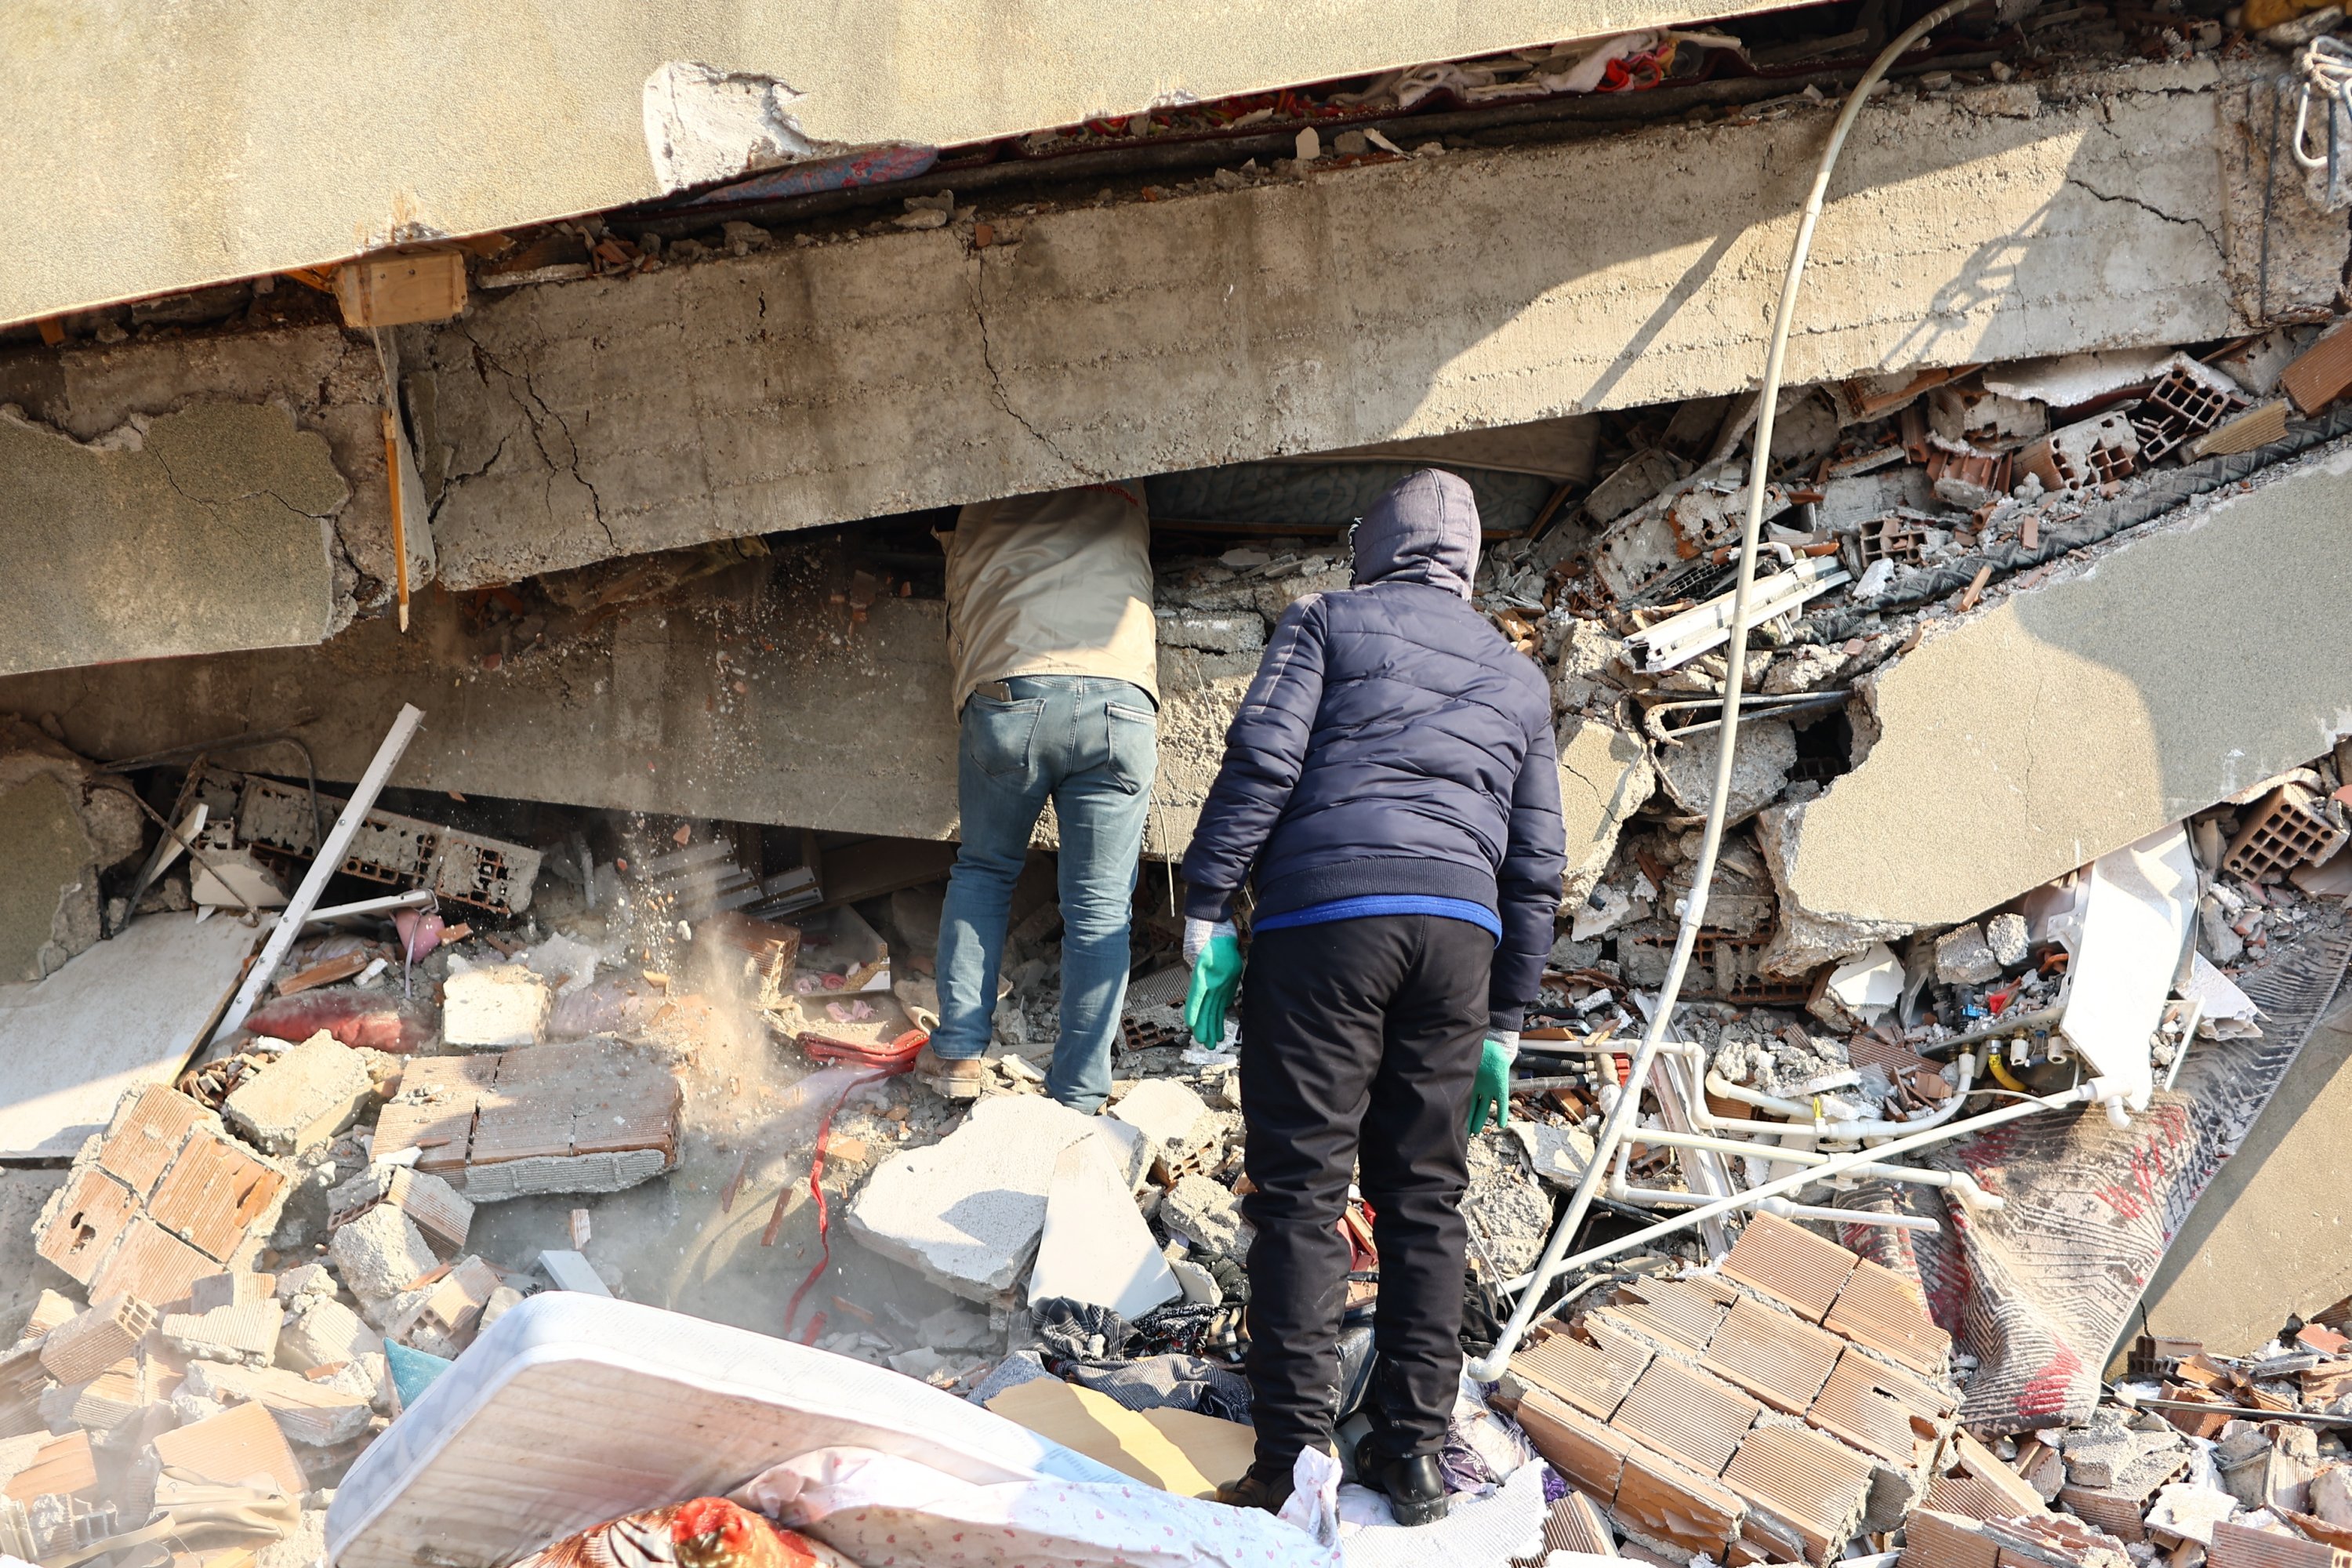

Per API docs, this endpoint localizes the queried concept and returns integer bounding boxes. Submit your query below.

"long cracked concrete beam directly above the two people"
[407,59,2347,588]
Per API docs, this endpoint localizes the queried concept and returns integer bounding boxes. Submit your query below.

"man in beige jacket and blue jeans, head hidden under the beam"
[915,485,1160,1112]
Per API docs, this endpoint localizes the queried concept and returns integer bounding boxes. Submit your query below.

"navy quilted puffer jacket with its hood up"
[1183,468,1566,1029]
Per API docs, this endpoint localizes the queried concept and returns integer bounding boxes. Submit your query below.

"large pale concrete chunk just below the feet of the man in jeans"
[842,1095,1145,1305]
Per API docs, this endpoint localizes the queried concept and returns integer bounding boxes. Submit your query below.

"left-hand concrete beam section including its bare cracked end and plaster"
[0,324,419,670]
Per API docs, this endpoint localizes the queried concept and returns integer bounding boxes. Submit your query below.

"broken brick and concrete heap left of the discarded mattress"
[0,912,680,1568]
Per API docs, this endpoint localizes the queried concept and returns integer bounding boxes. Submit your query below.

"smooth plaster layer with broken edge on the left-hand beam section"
[0,402,348,673]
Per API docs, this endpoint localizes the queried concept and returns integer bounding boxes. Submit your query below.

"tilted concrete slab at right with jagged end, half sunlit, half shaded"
[1759,442,2352,973]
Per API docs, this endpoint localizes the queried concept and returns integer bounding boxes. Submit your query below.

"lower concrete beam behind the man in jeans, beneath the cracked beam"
[0,567,1258,853]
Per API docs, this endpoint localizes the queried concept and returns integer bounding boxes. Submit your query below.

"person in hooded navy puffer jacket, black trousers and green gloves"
[1183,468,1566,1523]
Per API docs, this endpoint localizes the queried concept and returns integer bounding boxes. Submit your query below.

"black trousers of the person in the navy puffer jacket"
[1242,914,1494,1481]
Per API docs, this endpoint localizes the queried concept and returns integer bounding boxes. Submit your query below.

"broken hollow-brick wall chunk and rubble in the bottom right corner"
[1494,1215,2352,1568]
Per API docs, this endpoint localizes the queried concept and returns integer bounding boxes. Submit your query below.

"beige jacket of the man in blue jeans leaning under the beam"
[938,485,1160,713]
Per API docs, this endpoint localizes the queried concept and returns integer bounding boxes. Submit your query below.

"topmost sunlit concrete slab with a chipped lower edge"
[0,0,1806,322]
